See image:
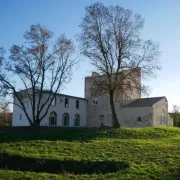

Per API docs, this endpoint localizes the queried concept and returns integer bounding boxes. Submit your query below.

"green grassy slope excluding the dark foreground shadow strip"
[0,128,180,179]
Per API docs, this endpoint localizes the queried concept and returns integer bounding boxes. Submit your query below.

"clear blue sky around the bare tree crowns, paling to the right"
[0,0,180,110]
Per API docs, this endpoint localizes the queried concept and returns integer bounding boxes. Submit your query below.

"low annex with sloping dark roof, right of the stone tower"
[118,97,170,127]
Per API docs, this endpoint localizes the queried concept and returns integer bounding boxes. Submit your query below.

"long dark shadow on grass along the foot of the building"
[0,127,110,142]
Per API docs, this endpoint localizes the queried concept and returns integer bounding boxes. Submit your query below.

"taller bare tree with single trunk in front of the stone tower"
[79,2,160,127]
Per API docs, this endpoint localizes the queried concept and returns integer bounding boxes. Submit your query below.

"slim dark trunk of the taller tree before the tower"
[110,91,120,128]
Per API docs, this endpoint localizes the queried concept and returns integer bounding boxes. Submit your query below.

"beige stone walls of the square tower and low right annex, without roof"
[85,71,170,127]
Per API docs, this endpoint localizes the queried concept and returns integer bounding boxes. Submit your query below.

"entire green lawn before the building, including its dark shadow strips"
[0,127,180,179]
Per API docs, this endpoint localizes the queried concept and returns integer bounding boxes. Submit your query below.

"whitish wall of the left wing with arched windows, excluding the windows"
[12,95,87,127]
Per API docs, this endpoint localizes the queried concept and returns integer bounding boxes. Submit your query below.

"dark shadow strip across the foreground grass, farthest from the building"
[0,154,129,174]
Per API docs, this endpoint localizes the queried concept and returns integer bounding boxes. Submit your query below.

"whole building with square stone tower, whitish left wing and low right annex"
[12,70,169,127]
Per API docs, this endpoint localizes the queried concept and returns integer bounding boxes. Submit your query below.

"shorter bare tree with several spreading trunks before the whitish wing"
[0,24,77,126]
